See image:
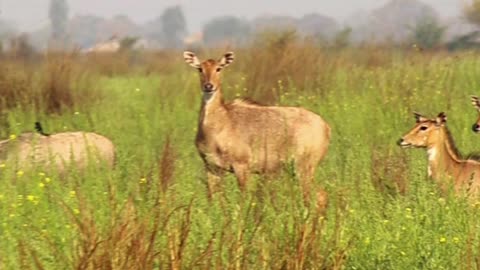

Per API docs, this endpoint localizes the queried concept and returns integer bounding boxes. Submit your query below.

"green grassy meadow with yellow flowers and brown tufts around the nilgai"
[0,40,480,269]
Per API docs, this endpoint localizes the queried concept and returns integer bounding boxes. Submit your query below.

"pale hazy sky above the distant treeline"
[0,0,465,31]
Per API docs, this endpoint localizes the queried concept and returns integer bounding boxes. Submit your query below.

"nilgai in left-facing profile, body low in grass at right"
[398,113,480,195]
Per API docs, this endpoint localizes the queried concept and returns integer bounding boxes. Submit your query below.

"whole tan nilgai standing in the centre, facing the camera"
[183,52,330,199]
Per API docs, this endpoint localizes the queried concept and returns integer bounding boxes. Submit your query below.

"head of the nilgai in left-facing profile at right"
[398,112,447,148]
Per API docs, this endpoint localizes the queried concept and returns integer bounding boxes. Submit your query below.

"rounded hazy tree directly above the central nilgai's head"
[203,16,251,45]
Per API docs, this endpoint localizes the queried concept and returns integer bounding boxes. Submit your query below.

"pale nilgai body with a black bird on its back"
[0,122,115,173]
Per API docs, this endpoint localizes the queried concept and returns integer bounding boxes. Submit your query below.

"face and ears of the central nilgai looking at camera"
[183,51,235,94]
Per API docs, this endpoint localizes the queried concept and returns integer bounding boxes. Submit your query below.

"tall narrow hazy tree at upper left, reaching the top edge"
[48,0,68,41]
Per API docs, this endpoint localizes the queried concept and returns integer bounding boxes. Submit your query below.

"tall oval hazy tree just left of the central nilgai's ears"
[160,6,187,48]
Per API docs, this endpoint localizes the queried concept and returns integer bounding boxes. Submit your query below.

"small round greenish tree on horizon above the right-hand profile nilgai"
[411,16,446,49]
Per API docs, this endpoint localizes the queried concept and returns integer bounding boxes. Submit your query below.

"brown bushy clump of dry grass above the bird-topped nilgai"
[0,54,101,114]
